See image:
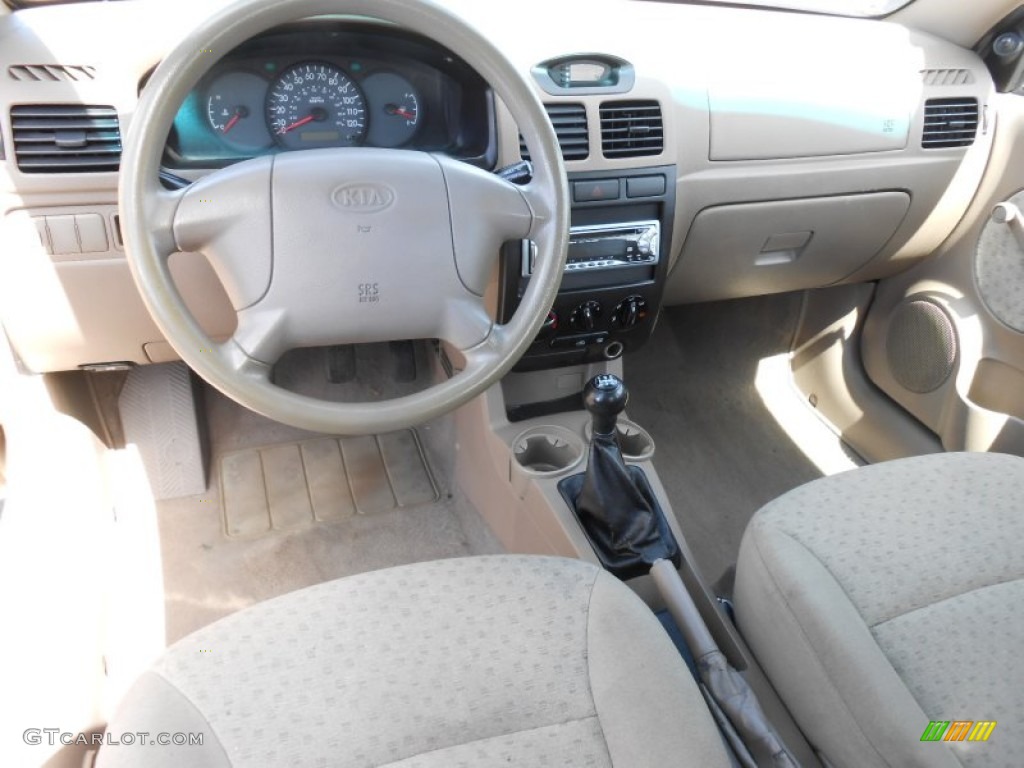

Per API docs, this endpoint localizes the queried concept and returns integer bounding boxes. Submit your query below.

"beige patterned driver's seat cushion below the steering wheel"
[97,556,728,768]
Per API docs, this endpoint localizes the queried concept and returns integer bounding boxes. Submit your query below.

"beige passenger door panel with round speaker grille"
[861,94,1024,455]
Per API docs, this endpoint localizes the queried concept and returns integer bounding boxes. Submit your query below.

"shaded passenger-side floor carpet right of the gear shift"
[625,294,824,592]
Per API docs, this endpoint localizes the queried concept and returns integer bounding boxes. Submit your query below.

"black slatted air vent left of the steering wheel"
[10,104,121,173]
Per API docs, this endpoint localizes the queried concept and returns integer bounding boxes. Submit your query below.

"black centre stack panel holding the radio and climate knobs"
[498,166,676,371]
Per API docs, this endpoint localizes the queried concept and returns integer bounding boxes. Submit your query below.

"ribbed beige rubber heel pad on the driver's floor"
[219,430,438,537]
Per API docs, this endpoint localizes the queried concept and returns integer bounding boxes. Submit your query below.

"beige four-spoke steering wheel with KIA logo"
[119,0,569,434]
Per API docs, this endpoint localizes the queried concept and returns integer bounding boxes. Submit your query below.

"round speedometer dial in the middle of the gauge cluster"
[266,61,367,150]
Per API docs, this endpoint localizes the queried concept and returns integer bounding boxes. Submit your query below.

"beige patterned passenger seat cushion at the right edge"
[734,454,1024,768]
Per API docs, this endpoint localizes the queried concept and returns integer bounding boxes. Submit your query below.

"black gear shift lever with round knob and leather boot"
[558,374,679,579]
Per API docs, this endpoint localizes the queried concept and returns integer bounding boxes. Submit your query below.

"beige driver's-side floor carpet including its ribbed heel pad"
[157,376,502,642]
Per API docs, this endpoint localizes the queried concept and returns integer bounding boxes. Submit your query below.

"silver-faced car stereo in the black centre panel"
[522,221,662,278]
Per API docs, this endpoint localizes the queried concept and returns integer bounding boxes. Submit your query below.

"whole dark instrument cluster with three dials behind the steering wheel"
[167,25,490,168]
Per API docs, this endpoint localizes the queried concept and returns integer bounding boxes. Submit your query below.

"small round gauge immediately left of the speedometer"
[206,72,273,152]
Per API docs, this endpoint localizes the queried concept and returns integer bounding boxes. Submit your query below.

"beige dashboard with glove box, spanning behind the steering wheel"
[0,0,996,371]
